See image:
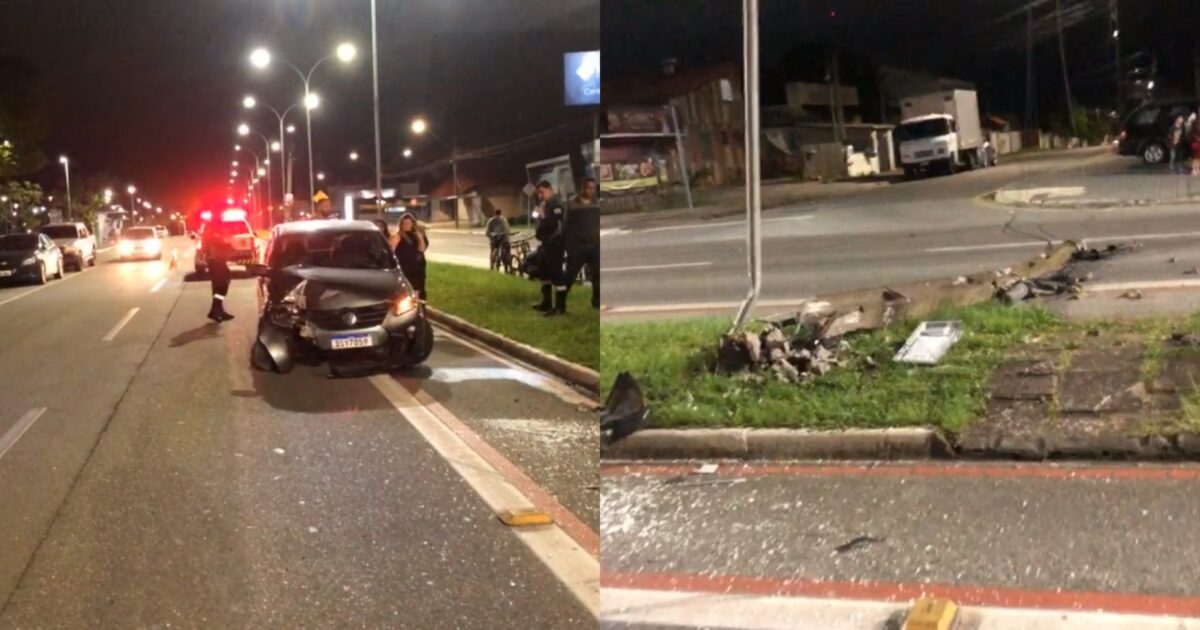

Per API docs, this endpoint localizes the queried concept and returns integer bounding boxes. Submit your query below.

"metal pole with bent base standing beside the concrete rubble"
[731,0,762,331]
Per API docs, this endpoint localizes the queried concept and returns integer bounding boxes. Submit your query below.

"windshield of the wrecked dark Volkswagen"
[271,230,396,269]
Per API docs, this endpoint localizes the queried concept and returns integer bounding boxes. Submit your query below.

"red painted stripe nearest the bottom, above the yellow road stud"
[600,571,1200,617]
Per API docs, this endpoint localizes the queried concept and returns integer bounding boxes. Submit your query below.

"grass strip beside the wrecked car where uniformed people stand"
[426,262,600,370]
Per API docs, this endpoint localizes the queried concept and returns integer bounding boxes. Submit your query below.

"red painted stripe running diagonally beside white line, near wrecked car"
[397,378,600,559]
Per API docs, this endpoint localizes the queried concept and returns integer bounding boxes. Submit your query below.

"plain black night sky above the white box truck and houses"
[601,0,1200,120]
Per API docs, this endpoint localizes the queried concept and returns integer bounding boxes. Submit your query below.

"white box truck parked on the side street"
[895,90,996,178]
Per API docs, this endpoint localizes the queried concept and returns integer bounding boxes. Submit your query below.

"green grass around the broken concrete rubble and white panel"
[601,305,1068,431]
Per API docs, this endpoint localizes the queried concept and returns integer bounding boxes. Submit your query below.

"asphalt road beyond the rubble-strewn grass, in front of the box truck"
[602,150,1200,317]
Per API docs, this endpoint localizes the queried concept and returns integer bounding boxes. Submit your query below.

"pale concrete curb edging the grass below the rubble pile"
[601,427,950,460]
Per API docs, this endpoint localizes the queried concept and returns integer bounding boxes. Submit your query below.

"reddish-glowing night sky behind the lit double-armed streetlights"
[0,0,599,208]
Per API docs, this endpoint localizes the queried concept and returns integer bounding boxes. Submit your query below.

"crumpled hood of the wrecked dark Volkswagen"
[280,266,409,311]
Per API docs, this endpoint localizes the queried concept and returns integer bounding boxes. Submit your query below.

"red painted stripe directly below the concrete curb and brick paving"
[600,463,1200,481]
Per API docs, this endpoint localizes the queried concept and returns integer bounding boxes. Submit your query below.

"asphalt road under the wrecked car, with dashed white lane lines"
[0,239,599,628]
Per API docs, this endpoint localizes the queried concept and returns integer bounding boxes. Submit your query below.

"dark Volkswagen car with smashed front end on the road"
[251,221,433,376]
